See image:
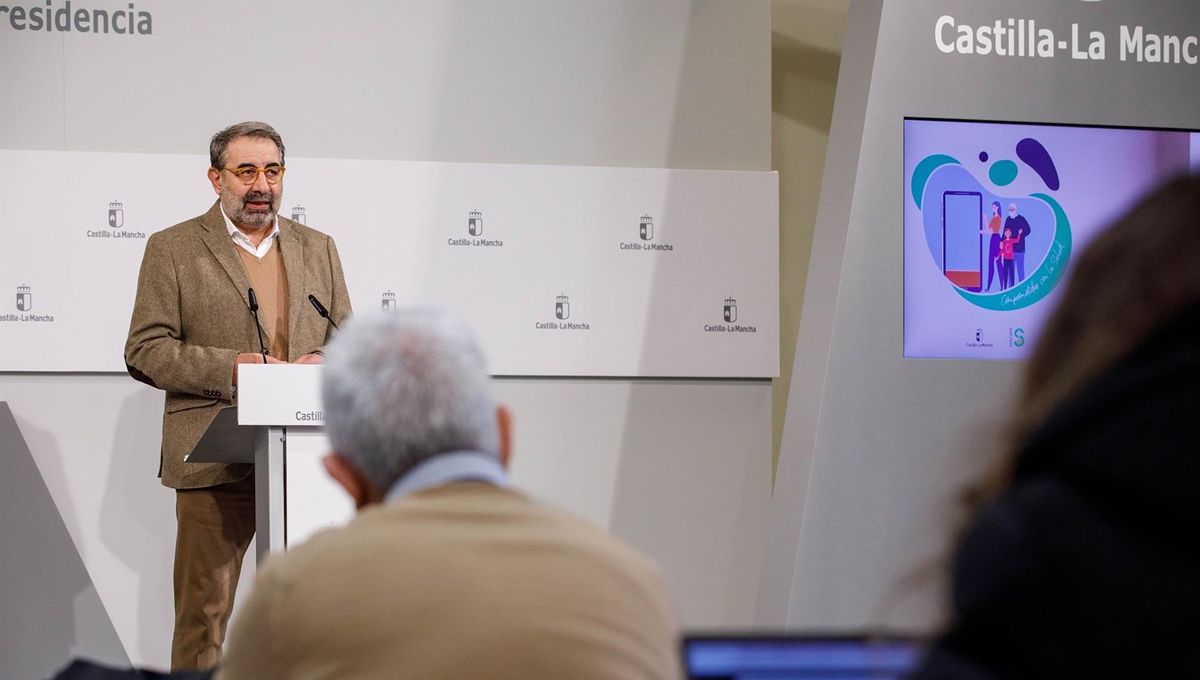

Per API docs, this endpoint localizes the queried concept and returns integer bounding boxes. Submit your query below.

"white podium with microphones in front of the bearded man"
[187,363,354,564]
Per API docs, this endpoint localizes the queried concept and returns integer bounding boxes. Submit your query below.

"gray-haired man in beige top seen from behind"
[218,309,679,680]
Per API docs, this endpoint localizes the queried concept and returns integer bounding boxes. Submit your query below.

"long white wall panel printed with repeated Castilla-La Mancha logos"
[0,150,779,378]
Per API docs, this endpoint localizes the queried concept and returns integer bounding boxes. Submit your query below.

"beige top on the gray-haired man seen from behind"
[217,482,680,680]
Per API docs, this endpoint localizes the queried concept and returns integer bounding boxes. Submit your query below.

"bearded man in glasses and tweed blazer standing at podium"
[125,122,350,669]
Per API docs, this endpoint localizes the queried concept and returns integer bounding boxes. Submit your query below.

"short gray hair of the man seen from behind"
[322,308,499,493]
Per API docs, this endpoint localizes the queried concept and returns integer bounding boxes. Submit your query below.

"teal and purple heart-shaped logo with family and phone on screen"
[910,137,1072,314]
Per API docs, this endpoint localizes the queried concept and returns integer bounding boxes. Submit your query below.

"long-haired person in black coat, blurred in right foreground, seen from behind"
[914,179,1200,679]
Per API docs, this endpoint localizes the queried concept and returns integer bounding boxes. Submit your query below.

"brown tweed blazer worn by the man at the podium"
[125,203,350,489]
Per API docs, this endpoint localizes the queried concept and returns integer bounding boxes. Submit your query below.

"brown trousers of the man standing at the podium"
[170,475,254,670]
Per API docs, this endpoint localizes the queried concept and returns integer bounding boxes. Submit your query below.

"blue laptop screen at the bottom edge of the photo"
[683,636,922,680]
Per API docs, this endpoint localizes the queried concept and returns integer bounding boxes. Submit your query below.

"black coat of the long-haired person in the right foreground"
[914,307,1200,678]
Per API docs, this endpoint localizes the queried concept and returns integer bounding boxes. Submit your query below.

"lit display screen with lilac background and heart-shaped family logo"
[904,118,1200,360]
